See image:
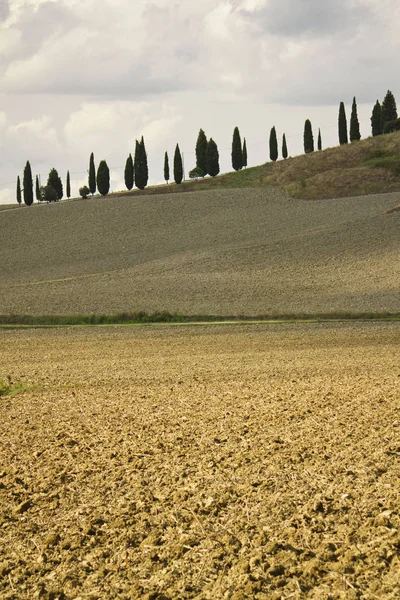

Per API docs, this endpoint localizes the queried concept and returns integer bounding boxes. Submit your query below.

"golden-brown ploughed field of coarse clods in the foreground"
[0,323,400,600]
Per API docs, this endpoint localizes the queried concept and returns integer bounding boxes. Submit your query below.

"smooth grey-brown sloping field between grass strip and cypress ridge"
[0,188,400,315]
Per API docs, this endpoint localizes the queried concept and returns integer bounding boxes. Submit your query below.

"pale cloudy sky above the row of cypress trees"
[0,0,400,203]
